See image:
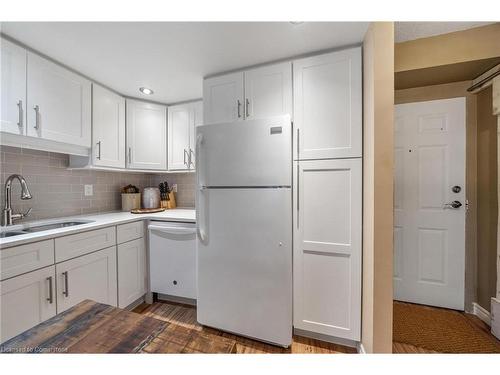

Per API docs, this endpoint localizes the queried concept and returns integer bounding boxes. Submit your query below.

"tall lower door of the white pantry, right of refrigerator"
[293,159,362,341]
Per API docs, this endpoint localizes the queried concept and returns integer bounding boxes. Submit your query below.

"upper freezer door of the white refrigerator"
[196,116,292,186]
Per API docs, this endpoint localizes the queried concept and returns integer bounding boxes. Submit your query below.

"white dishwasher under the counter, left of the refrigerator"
[148,221,196,299]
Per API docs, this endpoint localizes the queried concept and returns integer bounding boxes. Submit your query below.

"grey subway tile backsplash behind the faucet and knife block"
[0,146,195,223]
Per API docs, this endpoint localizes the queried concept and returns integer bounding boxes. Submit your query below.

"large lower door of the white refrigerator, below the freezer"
[197,188,292,346]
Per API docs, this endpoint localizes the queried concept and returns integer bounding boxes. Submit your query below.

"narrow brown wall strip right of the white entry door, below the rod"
[477,86,498,311]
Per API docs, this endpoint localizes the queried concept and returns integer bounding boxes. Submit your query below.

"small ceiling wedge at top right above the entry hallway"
[394,22,494,43]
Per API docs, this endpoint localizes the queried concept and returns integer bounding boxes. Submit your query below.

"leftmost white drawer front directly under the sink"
[0,240,54,280]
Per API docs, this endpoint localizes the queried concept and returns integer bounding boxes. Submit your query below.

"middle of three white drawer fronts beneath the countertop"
[55,227,116,263]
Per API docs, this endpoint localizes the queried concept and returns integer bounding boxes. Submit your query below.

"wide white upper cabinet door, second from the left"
[26,52,91,147]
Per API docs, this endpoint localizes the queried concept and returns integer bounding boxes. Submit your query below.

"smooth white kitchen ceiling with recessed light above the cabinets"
[1,22,369,103]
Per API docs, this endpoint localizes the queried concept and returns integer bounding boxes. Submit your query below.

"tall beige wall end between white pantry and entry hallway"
[361,22,394,353]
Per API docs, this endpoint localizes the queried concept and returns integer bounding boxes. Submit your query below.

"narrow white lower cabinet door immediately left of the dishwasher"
[118,238,146,308]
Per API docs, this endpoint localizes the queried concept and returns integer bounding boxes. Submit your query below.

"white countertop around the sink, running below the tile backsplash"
[0,208,196,249]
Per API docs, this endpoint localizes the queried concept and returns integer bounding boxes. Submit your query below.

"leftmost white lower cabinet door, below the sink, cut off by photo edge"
[0,266,56,342]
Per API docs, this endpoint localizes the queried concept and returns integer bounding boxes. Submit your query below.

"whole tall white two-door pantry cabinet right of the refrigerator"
[293,47,362,341]
